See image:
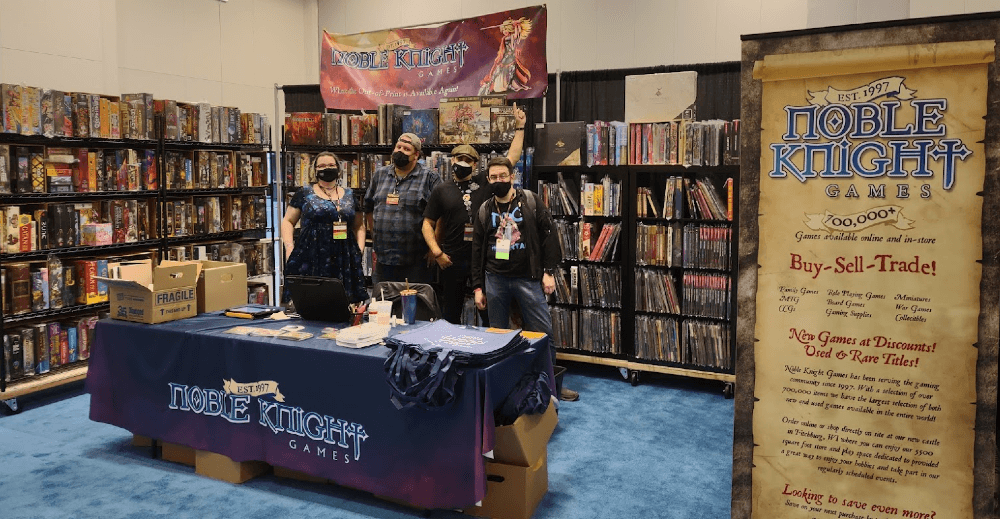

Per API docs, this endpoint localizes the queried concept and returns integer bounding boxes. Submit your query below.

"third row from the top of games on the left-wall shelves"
[0,195,267,254]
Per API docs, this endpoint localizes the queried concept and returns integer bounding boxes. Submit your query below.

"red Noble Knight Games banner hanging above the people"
[320,6,548,110]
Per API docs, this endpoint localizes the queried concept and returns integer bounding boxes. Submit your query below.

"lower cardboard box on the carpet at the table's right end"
[463,452,549,519]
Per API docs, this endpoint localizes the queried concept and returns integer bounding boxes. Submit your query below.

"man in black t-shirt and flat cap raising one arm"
[421,104,527,325]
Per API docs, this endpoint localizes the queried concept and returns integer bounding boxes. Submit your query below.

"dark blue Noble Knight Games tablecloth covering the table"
[86,314,554,508]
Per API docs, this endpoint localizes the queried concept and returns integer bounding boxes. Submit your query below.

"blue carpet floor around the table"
[0,365,733,519]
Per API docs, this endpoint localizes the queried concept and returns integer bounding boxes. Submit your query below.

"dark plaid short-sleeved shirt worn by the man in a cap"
[365,163,441,265]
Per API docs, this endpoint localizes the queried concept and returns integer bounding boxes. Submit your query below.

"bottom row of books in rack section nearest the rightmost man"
[549,306,622,354]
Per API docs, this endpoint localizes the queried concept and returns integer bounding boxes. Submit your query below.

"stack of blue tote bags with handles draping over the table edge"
[384,320,528,409]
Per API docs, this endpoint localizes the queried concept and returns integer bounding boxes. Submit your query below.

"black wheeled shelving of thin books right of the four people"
[534,158,739,395]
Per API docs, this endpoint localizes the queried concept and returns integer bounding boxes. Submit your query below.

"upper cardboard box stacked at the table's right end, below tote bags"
[493,397,559,467]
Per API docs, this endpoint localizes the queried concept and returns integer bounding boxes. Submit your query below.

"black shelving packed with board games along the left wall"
[0,104,275,411]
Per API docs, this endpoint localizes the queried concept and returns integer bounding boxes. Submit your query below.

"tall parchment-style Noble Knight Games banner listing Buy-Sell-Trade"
[752,41,994,519]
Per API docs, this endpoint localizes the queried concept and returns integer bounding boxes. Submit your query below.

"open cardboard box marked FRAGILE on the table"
[102,260,198,324]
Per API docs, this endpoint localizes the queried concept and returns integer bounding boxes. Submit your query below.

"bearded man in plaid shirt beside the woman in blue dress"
[365,133,441,283]
